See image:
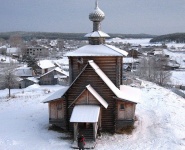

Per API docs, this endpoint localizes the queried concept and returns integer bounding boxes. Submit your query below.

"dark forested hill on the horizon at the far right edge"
[150,33,185,43]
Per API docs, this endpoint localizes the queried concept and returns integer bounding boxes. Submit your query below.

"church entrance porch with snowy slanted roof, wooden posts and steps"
[70,105,101,149]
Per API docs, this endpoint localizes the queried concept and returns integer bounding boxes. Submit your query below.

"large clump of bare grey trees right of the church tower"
[137,56,171,85]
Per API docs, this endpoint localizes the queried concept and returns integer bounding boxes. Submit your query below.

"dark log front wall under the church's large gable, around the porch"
[67,66,116,132]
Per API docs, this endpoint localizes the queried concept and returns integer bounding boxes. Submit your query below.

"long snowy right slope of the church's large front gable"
[89,60,139,102]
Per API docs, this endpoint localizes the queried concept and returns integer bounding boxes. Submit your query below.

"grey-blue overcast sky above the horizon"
[0,0,185,35]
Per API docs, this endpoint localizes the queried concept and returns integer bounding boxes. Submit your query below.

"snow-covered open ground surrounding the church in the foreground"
[0,81,185,150]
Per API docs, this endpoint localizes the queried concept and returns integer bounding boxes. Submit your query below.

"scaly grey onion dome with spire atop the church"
[89,1,105,22]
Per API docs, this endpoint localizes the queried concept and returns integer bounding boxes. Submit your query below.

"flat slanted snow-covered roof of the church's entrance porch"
[70,105,100,123]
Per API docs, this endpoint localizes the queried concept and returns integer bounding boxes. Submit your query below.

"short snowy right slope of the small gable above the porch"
[86,85,108,108]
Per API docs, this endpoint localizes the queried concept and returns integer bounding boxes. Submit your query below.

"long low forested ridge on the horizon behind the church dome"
[0,31,155,40]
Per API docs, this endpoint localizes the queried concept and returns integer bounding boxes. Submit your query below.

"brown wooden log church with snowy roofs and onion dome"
[44,1,138,146]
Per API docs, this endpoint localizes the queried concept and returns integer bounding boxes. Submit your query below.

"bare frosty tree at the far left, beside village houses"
[0,63,18,97]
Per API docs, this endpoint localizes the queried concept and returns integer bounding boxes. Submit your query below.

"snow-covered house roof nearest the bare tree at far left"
[15,67,33,77]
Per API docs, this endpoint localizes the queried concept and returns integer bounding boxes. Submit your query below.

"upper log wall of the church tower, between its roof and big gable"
[69,56,122,87]
